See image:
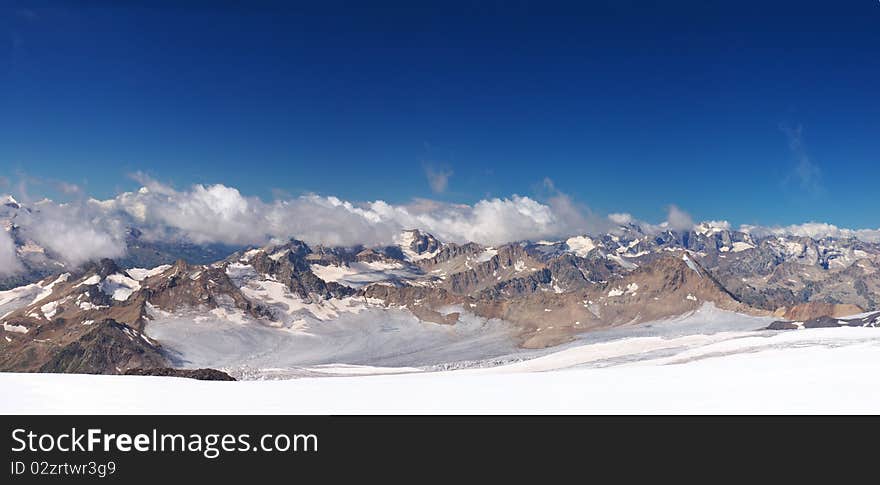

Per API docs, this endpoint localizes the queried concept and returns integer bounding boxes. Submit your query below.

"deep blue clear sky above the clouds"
[0,1,880,227]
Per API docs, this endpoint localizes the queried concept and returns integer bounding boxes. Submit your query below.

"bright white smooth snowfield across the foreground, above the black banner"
[0,328,880,414]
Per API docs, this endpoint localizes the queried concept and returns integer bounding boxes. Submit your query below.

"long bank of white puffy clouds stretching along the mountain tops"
[0,174,880,274]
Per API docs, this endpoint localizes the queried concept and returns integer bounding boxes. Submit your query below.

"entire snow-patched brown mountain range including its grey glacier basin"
[0,195,880,374]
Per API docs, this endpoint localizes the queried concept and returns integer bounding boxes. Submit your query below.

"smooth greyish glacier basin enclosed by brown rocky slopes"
[146,307,517,377]
